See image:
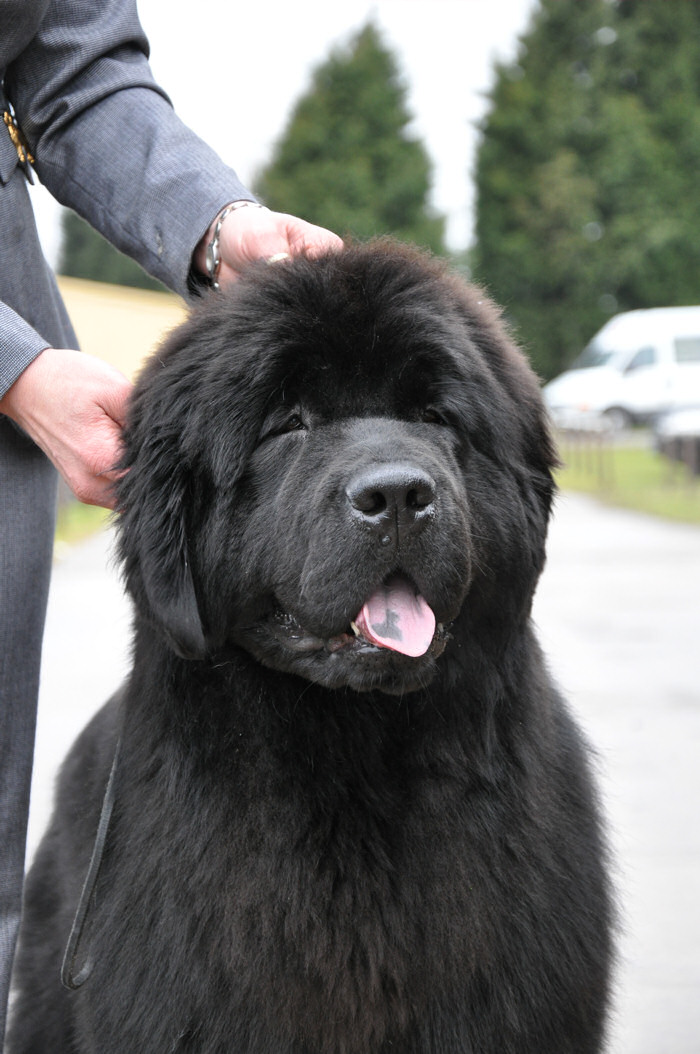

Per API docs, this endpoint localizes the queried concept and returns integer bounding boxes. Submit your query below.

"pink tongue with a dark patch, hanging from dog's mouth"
[355,578,435,657]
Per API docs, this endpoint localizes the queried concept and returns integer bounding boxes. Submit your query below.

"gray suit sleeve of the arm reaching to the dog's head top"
[6,0,254,296]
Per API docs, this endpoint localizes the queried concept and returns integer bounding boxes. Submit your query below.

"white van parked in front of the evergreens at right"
[543,307,700,428]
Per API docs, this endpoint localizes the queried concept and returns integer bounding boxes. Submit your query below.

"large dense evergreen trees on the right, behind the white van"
[473,0,700,377]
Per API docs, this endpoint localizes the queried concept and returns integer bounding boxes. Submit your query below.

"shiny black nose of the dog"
[346,464,435,544]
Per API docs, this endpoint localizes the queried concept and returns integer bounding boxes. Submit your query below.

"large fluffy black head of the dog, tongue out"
[118,242,555,692]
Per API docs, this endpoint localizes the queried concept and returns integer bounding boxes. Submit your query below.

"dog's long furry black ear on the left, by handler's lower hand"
[117,282,272,659]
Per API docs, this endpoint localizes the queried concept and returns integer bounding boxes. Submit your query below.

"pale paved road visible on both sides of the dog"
[31,495,700,1054]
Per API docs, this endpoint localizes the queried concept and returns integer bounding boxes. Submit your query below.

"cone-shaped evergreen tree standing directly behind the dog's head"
[256,22,444,252]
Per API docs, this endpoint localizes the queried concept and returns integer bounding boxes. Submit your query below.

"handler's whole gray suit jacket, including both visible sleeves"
[0,0,253,395]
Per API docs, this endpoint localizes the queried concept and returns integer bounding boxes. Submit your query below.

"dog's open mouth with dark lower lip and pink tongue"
[263,574,447,658]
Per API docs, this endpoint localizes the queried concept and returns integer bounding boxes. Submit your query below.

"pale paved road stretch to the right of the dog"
[536,496,700,1054]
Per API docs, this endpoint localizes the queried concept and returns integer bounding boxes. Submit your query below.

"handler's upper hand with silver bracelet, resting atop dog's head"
[194,202,343,286]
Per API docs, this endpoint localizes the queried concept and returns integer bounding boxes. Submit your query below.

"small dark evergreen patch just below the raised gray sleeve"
[57,209,164,290]
